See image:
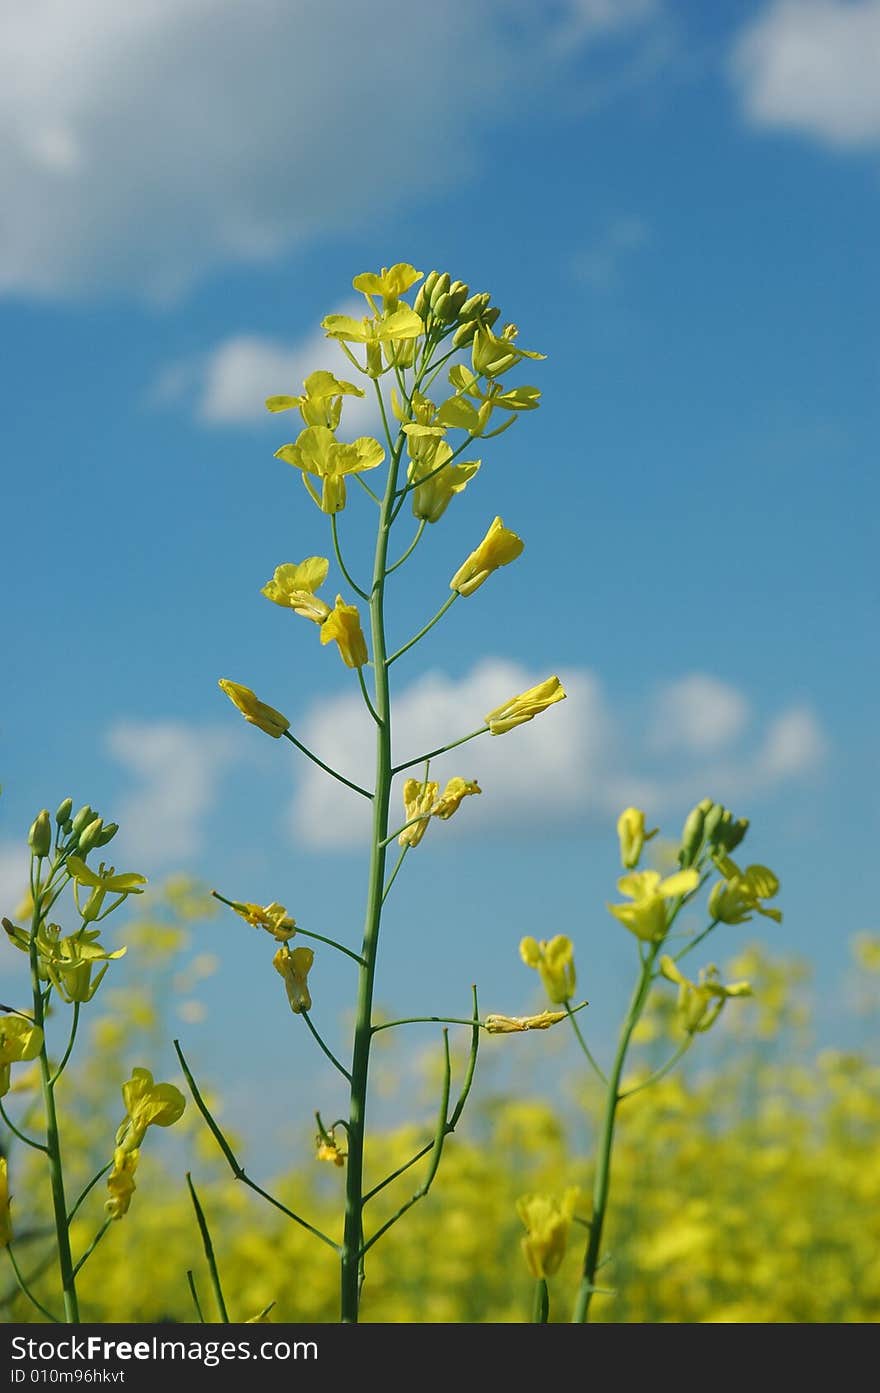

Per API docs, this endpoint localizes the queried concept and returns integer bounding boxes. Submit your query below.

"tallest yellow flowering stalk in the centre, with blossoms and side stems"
[196,262,565,1322]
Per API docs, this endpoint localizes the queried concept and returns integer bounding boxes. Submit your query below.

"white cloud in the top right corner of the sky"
[731,0,880,149]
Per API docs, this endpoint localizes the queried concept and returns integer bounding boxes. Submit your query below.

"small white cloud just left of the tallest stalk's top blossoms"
[149,301,377,436]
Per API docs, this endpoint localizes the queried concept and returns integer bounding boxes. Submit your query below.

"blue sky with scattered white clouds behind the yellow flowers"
[0,0,880,1147]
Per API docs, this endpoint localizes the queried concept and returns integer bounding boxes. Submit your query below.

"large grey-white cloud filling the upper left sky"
[0,0,656,298]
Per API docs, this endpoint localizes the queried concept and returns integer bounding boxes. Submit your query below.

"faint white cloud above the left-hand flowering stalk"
[107,720,238,864]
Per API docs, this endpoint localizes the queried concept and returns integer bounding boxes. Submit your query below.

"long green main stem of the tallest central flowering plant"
[340,389,402,1325]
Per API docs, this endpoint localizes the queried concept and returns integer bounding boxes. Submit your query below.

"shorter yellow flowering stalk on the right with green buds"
[519,798,783,1322]
